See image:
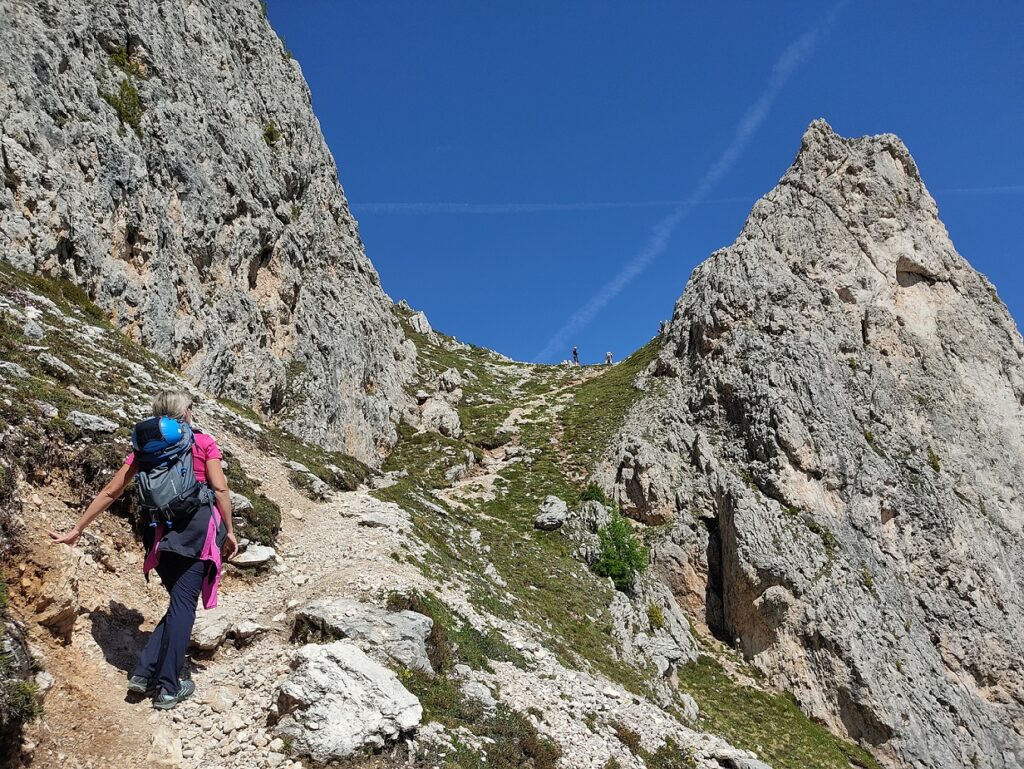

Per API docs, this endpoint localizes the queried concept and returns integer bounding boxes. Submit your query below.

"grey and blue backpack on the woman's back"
[131,417,205,528]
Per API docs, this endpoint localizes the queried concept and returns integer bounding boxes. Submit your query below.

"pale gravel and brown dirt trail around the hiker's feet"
[14,415,424,769]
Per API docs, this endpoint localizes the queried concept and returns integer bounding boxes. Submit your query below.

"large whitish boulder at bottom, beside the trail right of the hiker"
[278,641,423,763]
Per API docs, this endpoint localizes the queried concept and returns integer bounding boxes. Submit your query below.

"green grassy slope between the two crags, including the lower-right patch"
[378,313,879,769]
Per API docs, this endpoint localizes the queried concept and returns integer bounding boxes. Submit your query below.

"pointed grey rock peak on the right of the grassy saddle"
[604,121,1024,769]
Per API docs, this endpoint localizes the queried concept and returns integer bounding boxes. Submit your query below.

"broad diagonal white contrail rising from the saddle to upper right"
[534,0,846,361]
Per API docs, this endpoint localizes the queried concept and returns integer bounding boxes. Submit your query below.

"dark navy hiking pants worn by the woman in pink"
[132,553,206,694]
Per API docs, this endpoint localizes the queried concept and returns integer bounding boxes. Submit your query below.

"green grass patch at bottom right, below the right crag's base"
[679,655,881,769]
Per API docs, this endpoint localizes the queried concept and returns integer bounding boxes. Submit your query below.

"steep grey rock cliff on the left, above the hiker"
[0,0,415,463]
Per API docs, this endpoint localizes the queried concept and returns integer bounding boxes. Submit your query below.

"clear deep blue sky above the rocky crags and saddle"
[269,0,1024,362]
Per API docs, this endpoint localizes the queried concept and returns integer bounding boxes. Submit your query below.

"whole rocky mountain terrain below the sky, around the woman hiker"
[0,0,1024,769]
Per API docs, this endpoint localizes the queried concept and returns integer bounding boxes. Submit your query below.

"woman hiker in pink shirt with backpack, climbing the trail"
[50,390,239,710]
